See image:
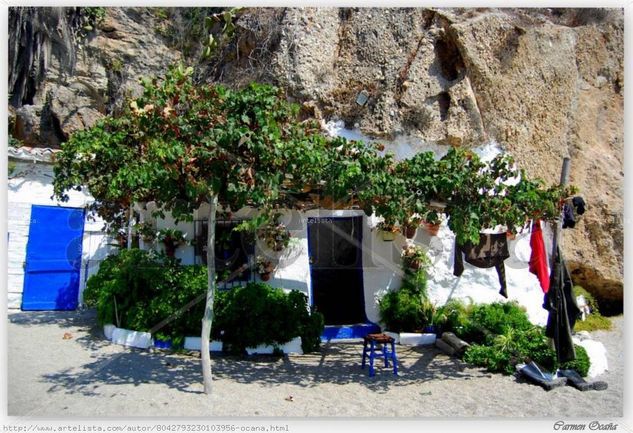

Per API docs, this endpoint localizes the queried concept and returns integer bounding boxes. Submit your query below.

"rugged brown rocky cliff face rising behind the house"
[10,8,624,310]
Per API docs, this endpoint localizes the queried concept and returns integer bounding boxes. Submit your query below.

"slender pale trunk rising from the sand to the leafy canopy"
[200,195,218,395]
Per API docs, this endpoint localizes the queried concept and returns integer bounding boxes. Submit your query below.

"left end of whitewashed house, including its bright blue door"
[7,147,112,310]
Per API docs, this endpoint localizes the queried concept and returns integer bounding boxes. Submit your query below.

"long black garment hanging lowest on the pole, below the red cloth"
[543,249,581,363]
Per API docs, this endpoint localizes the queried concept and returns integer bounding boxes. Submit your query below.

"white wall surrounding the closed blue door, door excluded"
[7,161,112,309]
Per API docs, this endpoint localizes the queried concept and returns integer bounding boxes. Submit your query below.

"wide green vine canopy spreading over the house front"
[54,65,573,243]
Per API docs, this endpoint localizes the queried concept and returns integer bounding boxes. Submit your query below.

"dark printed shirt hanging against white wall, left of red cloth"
[453,233,510,298]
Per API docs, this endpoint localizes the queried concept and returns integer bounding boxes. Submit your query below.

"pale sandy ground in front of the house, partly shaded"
[8,311,624,419]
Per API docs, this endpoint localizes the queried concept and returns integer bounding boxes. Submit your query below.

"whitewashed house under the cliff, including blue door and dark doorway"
[8,124,551,337]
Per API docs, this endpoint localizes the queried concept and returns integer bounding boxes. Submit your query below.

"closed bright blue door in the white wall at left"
[22,205,84,310]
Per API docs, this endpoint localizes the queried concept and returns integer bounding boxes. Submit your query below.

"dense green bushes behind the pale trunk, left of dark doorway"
[84,249,323,352]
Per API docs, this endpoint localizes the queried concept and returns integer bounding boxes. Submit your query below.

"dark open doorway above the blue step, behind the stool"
[308,217,367,325]
